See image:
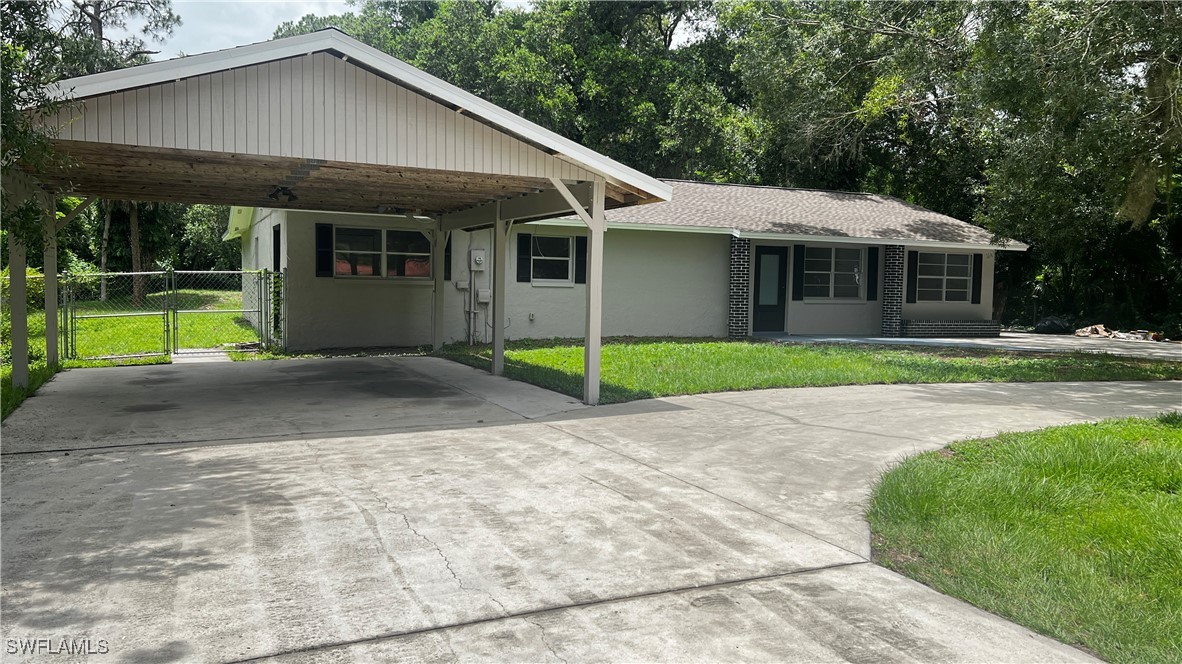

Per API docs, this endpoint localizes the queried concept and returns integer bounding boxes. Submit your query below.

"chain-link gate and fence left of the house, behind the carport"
[60,271,285,359]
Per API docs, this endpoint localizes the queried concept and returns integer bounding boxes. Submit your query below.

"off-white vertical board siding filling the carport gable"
[50,52,596,180]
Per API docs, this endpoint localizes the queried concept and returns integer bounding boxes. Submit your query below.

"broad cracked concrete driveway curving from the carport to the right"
[0,358,1182,662]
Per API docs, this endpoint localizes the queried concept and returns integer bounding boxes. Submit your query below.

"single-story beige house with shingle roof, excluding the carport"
[227,181,1026,350]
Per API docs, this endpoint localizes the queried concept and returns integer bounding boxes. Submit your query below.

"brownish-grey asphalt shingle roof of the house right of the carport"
[605,180,1007,245]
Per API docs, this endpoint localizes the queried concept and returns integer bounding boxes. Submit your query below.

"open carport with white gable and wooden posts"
[8,28,670,404]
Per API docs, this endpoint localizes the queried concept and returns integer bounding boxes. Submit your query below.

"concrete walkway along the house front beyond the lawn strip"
[756,332,1182,362]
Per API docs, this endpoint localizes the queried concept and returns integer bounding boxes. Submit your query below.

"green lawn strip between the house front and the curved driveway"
[440,339,1182,403]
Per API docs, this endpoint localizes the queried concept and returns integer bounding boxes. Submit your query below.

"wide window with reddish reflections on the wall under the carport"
[332,227,431,279]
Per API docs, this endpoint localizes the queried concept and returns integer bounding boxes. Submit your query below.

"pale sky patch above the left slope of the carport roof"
[119,0,352,60]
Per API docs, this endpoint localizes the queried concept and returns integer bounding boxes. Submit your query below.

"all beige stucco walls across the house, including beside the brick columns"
[242,209,994,350]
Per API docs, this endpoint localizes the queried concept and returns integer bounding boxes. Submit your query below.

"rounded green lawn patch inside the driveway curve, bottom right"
[868,412,1182,663]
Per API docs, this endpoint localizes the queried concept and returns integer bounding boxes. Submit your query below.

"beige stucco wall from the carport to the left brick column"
[265,211,729,350]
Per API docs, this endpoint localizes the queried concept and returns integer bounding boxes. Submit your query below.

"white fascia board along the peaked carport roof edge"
[51,30,673,201]
